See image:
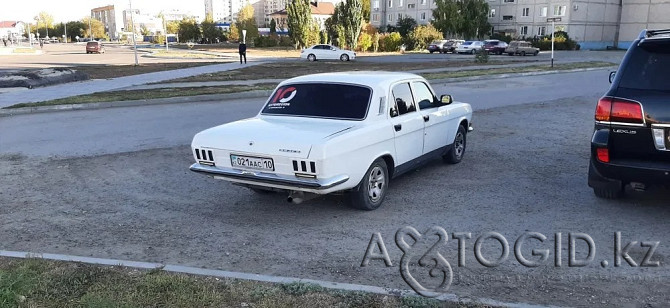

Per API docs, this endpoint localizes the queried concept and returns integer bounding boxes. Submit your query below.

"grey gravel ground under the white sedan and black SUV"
[0,97,670,307]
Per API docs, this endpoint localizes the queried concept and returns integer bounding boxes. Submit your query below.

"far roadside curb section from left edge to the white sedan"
[0,90,273,117]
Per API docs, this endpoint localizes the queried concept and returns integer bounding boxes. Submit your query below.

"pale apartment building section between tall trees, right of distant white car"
[370,0,437,28]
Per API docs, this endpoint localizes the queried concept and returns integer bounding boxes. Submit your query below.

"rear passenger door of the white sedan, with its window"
[389,82,424,168]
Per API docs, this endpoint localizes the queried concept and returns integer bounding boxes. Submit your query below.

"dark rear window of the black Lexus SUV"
[619,40,670,92]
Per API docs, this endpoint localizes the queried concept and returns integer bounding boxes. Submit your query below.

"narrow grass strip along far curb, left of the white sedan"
[5,83,277,109]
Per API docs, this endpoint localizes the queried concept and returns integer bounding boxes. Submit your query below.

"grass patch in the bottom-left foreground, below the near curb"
[0,258,486,308]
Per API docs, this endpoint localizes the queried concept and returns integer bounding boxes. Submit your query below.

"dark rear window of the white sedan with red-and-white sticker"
[261,83,372,120]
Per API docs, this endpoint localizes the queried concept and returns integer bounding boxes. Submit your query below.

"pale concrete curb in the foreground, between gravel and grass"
[0,250,556,308]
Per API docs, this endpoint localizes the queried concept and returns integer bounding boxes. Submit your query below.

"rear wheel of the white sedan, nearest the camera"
[350,158,390,211]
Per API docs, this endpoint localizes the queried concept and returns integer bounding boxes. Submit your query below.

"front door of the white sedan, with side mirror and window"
[412,81,453,154]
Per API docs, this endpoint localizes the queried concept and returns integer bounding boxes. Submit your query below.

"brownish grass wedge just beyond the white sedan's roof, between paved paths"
[164,60,532,83]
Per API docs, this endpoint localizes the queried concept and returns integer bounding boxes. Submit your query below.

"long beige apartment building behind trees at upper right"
[370,0,670,49]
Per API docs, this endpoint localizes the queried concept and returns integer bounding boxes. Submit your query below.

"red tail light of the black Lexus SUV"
[596,96,644,124]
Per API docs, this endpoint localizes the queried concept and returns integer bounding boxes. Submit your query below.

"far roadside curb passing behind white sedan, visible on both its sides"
[0,66,615,117]
